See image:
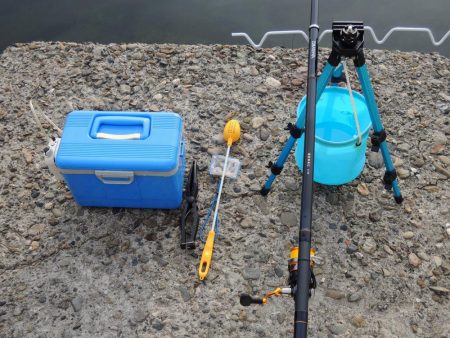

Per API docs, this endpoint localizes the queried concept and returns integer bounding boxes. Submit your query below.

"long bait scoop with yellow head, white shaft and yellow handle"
[198,120,241,280]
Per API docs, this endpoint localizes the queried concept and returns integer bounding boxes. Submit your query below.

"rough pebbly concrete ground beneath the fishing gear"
[0,43,450,338]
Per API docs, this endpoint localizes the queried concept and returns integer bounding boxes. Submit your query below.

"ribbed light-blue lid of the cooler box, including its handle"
[55,111,182,172]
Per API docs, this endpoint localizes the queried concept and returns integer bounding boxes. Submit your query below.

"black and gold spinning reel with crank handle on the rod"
[240,246,318,306]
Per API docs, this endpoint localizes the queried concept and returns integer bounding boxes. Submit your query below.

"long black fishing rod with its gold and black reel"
[240,0,319,338]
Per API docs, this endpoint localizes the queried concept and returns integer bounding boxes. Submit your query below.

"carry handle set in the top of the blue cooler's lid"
[90,115,150,140]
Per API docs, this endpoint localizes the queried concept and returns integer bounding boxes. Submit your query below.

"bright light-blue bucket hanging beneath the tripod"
[295,86,372,185]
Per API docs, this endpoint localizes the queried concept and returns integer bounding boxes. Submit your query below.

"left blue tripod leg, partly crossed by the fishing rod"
[261,62,335,196]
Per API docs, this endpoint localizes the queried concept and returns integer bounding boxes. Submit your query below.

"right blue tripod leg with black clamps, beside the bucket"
[356,64,403,204]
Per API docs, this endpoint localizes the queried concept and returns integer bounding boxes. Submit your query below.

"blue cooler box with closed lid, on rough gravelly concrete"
[55,111,185,209]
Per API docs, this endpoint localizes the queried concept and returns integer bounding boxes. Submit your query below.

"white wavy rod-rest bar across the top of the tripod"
[231,26,450,48]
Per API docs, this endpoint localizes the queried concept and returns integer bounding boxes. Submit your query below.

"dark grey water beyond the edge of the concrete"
[0,0,450,56]
